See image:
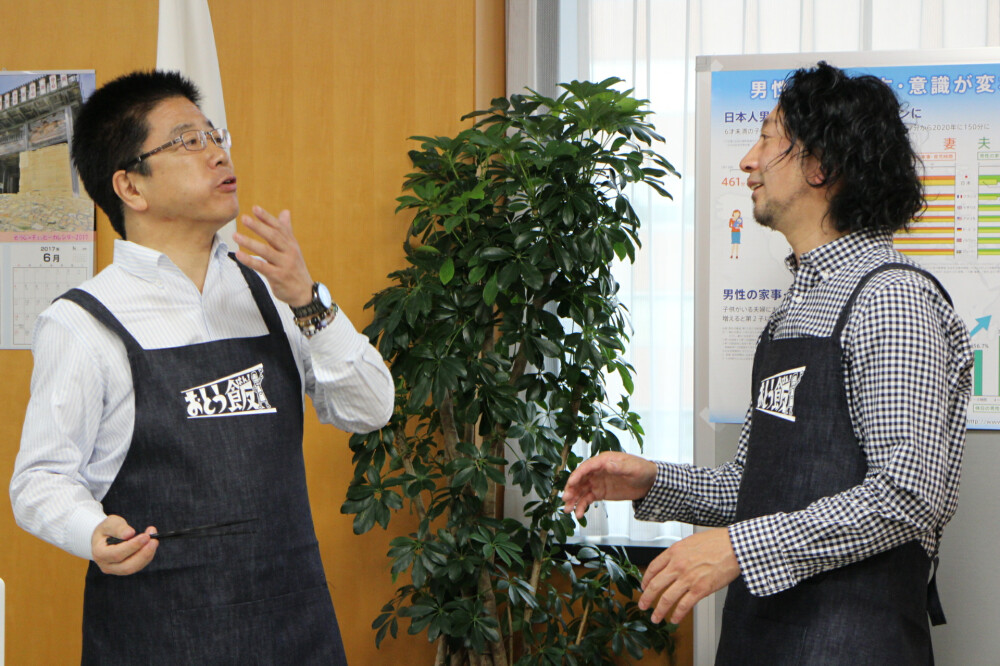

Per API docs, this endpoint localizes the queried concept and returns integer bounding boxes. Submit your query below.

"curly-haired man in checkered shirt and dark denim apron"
[564,62,972,665]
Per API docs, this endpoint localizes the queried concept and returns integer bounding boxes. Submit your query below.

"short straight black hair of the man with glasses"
[73,70,201,238]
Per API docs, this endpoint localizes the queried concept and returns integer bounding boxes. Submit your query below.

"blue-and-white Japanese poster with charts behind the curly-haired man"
[697,50,1000,429]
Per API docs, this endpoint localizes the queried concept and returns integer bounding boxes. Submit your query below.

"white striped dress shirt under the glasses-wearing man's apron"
[10,239,394,559]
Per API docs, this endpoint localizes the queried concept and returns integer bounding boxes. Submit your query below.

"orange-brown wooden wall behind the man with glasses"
[0,0,504,664]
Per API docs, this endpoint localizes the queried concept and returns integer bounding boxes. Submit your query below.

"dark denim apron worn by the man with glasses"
[62,255,346,666]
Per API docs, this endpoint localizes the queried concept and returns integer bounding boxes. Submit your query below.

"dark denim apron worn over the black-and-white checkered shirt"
[716,263,947,666]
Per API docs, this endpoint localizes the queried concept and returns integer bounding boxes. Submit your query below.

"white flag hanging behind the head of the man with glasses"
[156,0,236,244]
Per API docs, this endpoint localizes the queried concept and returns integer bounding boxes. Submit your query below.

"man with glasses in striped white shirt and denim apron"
[10,72,393,664]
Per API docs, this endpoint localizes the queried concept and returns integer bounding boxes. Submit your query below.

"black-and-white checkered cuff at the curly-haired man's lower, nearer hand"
[729,514,798,597]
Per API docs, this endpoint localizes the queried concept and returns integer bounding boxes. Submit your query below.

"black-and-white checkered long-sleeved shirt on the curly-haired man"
[635,231,973,596]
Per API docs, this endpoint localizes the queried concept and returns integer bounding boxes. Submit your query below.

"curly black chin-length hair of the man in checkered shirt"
[778,62,924,232]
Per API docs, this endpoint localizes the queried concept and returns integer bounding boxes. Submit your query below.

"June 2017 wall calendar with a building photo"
[0,70,95,349]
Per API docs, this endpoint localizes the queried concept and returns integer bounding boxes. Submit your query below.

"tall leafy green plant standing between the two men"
[342,78,677,666]
